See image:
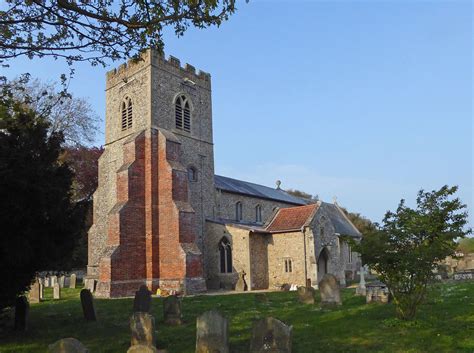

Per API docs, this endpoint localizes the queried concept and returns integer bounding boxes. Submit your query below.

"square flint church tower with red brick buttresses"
[87,50,214,297]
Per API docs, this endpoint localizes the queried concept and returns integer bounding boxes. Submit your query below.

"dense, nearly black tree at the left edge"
[0,96,84,308]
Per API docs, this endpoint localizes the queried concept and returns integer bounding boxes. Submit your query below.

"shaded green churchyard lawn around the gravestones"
[0,282,474,353]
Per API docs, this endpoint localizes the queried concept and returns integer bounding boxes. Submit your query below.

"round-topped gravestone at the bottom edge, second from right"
[196,309,229,353]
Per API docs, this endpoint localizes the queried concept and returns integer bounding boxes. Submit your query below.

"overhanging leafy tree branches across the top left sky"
[0,0,241,65]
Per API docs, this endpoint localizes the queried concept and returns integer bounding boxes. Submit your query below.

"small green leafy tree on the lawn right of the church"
[354,186,471,320]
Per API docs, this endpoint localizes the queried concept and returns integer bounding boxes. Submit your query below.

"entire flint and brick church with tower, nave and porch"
[86,50,361,297]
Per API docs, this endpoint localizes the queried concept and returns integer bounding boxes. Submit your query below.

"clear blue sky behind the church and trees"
[2,0,474,224]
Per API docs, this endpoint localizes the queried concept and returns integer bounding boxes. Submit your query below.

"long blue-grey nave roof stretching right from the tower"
[214,175,306,205]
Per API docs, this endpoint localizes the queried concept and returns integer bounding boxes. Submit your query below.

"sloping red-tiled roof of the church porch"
[266,204,319,233]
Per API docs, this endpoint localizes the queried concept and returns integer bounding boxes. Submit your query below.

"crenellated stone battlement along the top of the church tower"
[106,49,211,87]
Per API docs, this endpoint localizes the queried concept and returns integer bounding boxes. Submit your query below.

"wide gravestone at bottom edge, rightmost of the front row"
[250,317,293,353]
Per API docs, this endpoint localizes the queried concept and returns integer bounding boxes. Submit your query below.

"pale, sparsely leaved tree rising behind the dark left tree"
[7,76,99,146]
